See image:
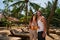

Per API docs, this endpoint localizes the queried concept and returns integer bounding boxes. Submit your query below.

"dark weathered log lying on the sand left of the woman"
[9,30,30,40]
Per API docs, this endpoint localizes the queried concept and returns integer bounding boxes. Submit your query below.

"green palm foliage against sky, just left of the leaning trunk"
[41,1,53,19]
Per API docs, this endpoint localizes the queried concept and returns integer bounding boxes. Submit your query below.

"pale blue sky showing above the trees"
[0,0,60,9]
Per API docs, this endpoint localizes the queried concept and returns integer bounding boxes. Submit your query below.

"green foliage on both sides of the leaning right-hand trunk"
[41,2,60,27]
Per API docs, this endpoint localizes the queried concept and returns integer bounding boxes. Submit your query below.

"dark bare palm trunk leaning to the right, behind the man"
[47,0,58,38]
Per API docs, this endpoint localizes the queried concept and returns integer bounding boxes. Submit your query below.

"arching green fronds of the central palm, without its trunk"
[9,0,40,13]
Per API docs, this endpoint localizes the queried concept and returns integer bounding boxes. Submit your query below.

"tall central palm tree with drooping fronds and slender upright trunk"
[10,0,40,22]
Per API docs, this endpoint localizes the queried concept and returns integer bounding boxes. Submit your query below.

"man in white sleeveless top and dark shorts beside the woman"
[36,10,47,40]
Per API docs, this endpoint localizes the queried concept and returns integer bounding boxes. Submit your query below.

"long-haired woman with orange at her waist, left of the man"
[29,14,37,40]
